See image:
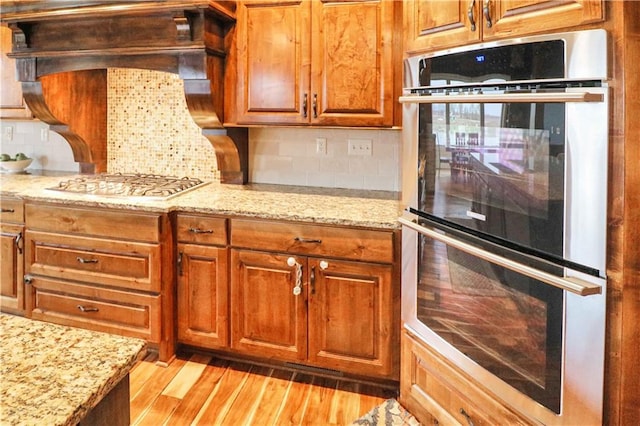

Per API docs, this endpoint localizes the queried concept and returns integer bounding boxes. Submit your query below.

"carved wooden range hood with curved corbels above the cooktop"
[0,0,248,184]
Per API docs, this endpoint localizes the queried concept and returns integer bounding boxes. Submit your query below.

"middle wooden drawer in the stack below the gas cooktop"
[25,230,162,293]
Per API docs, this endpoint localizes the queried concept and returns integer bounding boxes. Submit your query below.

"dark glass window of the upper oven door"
[418,100,565,257]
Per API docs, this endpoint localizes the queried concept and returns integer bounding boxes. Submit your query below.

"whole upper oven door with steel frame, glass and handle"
[401,87,608,276]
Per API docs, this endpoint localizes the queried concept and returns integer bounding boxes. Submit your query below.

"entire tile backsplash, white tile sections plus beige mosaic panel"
[1,68,401,191]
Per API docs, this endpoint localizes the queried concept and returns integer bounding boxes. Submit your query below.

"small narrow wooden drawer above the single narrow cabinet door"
[176,214,228,245]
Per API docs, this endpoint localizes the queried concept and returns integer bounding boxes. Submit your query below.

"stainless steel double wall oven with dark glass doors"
[400,30,608,424]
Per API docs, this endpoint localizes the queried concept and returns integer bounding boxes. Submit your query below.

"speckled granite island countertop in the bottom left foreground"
[0,314,146,425]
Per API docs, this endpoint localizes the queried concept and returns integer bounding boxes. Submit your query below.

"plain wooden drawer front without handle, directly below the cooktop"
[25,204,161,242]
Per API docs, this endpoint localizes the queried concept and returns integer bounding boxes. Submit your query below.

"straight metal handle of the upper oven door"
[398,92,604,104]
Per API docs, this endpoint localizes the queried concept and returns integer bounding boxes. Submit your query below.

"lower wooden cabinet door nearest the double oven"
[308,258,398,378]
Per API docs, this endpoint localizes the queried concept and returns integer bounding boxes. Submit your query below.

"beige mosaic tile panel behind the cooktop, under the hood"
[107,68,217,180]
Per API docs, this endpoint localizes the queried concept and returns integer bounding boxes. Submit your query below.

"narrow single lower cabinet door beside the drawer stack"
[178,244,229,349]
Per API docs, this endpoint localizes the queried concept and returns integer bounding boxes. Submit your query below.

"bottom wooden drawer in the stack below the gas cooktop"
[27,277,161,344]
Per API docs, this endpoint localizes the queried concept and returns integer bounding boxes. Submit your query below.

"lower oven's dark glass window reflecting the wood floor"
[417,236,563,413]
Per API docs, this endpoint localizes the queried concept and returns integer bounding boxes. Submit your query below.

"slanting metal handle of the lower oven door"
[398,217,602,296]
